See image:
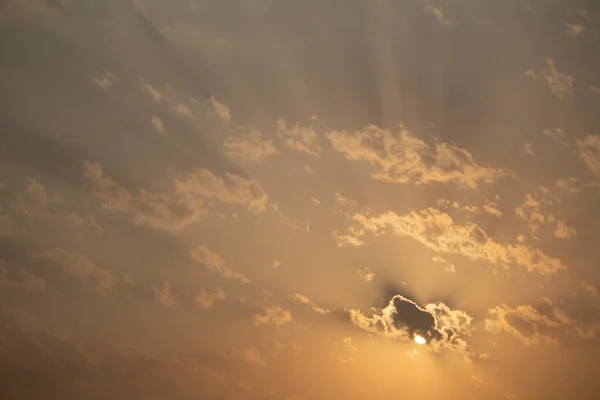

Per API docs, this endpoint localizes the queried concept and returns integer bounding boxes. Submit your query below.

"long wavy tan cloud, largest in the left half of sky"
[83,162,269,231]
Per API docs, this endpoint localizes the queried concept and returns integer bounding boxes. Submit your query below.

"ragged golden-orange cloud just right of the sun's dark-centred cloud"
[485,304,573,346]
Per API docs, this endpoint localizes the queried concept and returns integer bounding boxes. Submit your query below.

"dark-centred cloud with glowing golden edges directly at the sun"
[349,295,473,356]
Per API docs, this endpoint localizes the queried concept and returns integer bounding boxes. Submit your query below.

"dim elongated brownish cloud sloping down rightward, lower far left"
[32,248,118,291]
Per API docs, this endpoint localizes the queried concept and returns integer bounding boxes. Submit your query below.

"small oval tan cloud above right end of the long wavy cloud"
[223,129,279,161]
